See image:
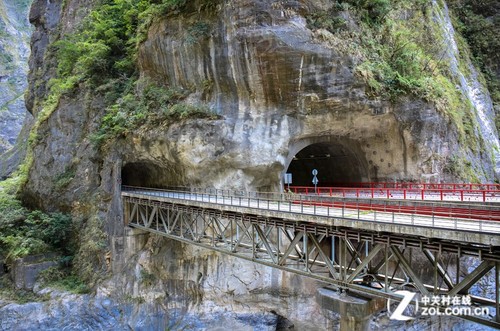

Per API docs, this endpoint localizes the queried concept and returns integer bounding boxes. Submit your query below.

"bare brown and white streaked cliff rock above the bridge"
[24,1,498,213]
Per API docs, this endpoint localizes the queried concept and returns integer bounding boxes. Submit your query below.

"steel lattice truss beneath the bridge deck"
[122,196,500,328]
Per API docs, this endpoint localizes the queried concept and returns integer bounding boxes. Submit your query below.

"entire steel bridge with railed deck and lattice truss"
[122,186,500,328]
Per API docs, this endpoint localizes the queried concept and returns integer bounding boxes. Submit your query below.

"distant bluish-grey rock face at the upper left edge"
[0,0,31,158]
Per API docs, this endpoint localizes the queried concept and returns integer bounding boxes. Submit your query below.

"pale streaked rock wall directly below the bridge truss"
[103,230,335,330]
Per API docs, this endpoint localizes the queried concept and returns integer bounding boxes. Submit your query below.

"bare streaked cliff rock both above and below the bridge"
[13,0,498,328]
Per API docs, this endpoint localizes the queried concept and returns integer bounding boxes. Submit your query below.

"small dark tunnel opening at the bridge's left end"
[121,161,183,188]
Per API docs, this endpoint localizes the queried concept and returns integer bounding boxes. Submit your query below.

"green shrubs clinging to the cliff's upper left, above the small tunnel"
[51,0,216,146]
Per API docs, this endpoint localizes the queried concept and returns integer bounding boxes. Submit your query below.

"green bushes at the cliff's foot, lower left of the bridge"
[0,177,98,296]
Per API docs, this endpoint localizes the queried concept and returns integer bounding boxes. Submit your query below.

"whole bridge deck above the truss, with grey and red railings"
[122,186,500,233]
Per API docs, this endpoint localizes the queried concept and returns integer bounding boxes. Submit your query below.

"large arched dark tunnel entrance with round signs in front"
[286,142,368,187]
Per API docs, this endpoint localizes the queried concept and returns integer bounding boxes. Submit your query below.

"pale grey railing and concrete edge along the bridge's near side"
[124,190,500,234]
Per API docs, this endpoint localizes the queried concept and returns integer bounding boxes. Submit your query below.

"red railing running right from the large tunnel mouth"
[290,184,500,202]
